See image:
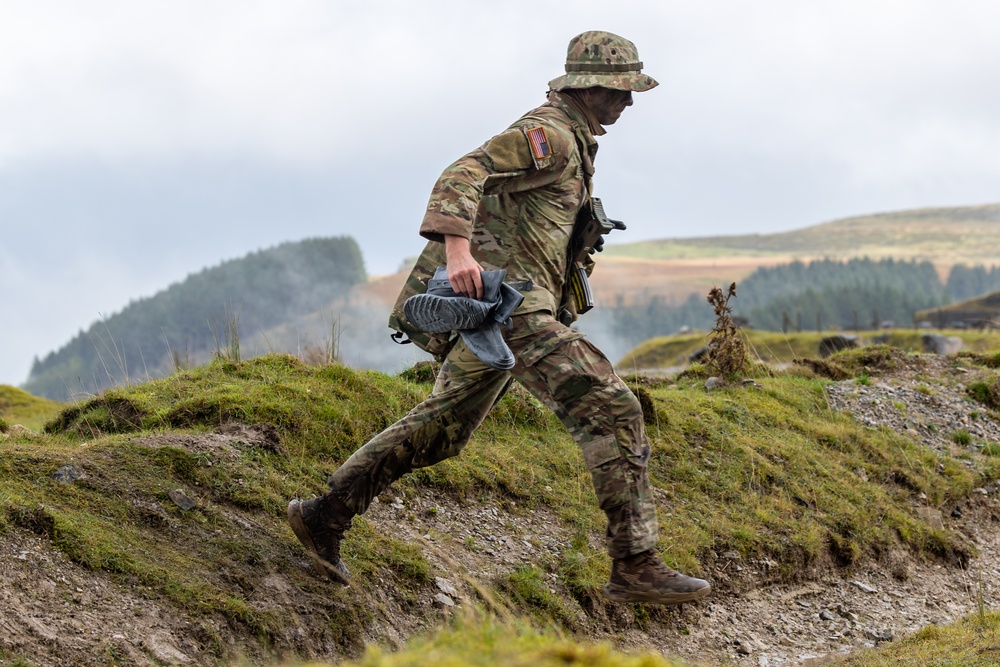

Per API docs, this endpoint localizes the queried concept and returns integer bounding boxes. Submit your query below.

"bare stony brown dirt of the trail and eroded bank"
[0,365,1000,667]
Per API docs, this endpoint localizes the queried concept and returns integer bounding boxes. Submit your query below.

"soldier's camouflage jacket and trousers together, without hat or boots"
[329,82,657,558]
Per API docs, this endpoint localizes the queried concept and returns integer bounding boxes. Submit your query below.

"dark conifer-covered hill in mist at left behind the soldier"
[23,237,366,400]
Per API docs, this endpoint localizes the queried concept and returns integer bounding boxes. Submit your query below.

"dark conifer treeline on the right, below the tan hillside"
[607,258,1000,345]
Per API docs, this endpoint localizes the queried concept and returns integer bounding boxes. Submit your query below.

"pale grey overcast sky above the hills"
[0,0,1000,385]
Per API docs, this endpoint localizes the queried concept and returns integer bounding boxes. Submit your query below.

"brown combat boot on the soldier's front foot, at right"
[604,549,712,604]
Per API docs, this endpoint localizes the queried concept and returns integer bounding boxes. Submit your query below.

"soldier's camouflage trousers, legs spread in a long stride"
[329,312,657,558]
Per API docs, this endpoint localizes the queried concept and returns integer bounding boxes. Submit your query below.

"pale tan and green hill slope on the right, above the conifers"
[592,204,1000,305]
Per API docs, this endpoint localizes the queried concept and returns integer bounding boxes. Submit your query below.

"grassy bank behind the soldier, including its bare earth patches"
[0,348,1000,665]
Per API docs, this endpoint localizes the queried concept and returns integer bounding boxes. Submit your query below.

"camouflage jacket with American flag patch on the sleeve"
[389,93,597,356]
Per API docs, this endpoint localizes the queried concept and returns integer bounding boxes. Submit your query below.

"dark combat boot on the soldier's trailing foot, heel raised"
[288,493,354,586]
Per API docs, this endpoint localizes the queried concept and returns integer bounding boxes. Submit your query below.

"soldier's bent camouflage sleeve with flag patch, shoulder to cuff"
[420,123,575,242]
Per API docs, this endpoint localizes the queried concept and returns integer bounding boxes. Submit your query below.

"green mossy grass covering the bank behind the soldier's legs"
[0,348,1000,665]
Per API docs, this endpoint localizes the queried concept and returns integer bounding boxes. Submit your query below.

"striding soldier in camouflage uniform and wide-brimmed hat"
[288,31,711,604]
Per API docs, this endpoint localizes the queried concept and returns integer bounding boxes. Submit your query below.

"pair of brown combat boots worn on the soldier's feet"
[288,493,712,605]
